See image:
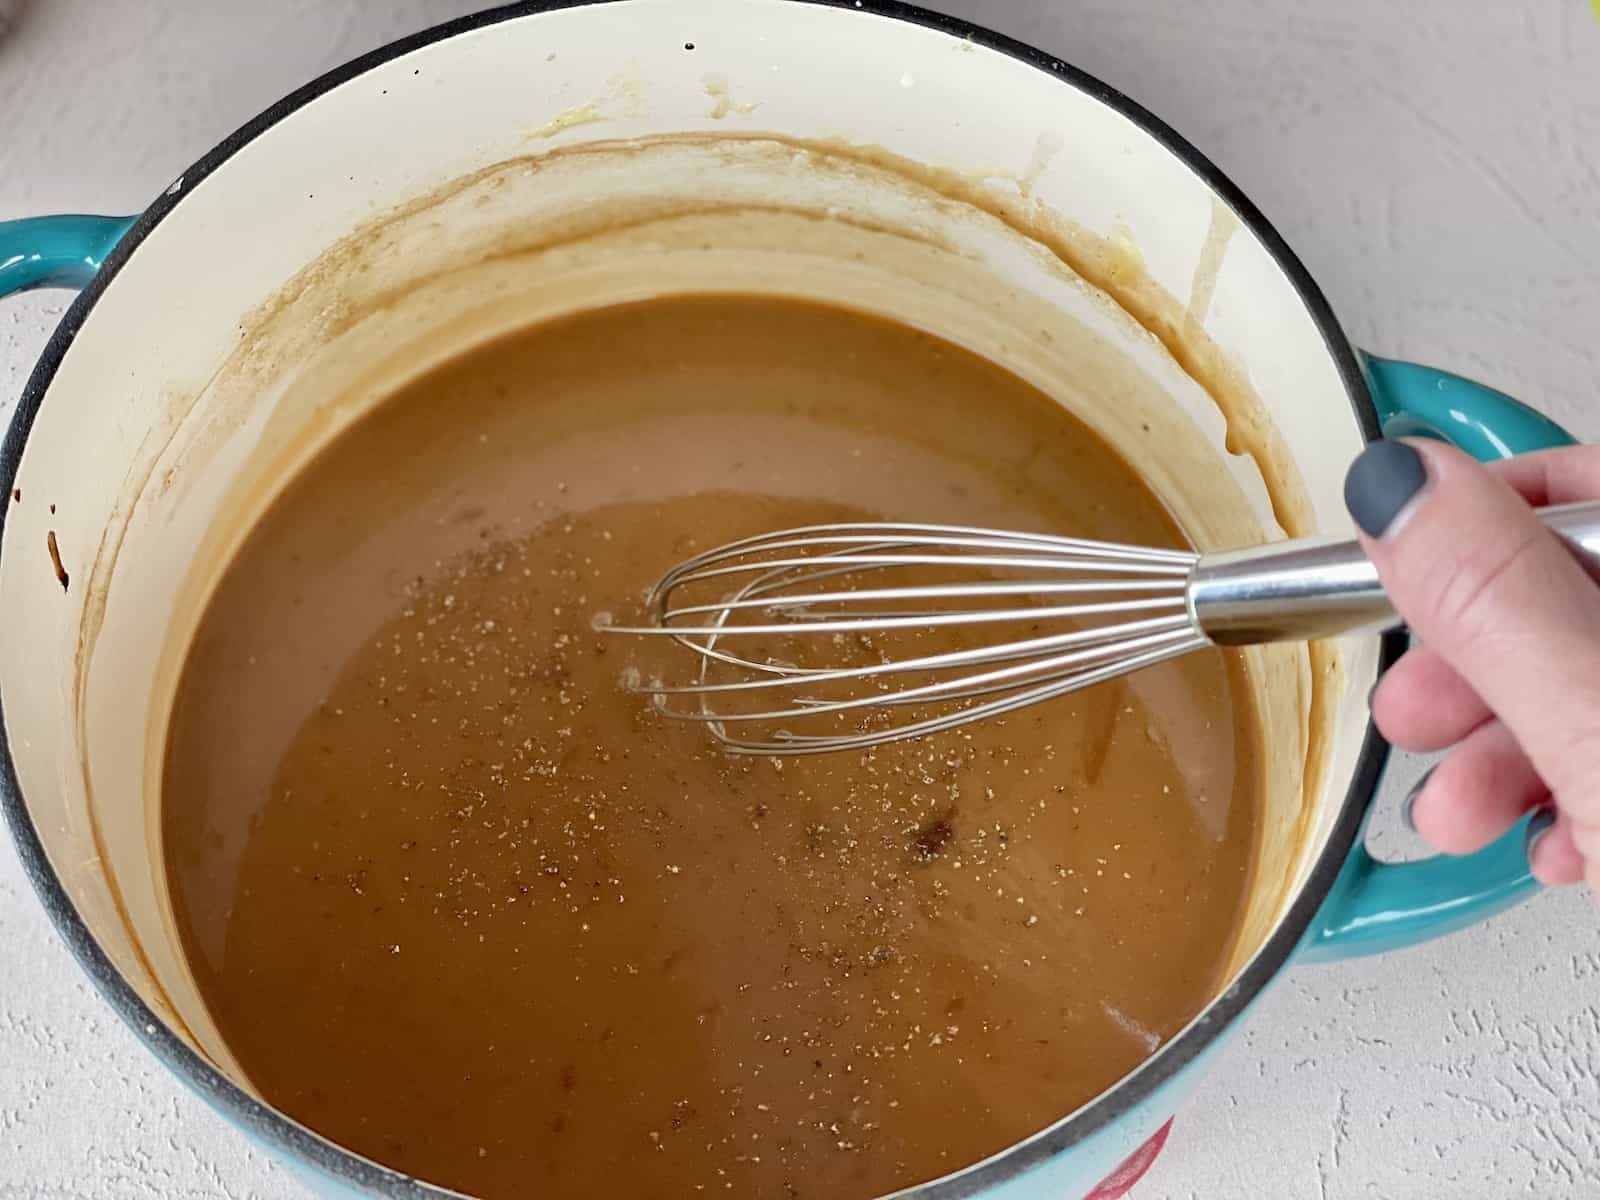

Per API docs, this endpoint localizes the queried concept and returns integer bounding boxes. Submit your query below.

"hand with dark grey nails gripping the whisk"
[1344,442,1600,890]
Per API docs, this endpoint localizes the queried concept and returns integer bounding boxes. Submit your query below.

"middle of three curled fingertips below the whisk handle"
[1411,720,1550,854]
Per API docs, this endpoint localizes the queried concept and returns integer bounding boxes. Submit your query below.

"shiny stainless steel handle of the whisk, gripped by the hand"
[1187,501,1600,646]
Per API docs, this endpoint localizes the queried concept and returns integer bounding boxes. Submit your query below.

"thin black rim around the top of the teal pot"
[0,0,1405,1200]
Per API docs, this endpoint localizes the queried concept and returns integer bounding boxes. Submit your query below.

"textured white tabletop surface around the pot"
[0,0,1600,1200]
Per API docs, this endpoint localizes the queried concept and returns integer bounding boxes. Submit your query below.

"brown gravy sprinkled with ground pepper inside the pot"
[162,296,1258,1200]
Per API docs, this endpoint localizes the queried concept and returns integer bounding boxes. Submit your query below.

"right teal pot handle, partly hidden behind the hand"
[1301,355,1574,962]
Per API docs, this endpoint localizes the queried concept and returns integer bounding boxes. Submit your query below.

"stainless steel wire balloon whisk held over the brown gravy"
[595,502,1600,755]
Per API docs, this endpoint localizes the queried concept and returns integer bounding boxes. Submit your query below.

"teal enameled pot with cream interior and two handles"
[0,0,1568,1200]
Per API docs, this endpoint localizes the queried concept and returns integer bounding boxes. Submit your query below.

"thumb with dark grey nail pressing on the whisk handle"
[1344,442,1600,821]
